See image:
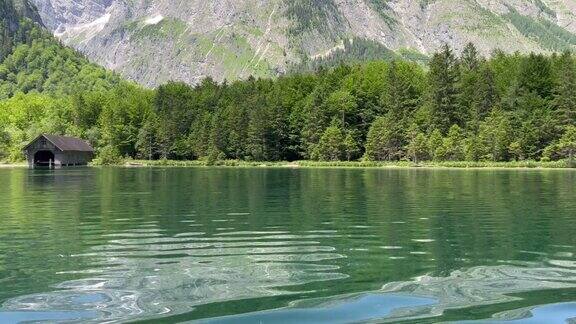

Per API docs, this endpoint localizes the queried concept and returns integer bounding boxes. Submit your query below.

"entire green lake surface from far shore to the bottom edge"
[0,168,576,323]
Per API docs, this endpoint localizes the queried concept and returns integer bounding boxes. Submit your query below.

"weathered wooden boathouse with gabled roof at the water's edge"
[24,134,94,168]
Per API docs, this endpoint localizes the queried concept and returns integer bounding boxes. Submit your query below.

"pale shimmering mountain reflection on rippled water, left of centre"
[0,223,347,322]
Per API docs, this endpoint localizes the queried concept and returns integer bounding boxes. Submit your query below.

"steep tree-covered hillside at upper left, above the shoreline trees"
[0,0,121,100]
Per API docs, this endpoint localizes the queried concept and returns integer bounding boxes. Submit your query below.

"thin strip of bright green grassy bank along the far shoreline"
[111,160,568,169]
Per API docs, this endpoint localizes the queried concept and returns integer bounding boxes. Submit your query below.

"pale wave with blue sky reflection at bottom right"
[196,266,576,324]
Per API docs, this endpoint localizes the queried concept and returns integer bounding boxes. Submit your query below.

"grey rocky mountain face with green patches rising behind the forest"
[32,0,576,86]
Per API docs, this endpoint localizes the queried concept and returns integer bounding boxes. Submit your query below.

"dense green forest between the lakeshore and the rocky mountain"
[0,25,576,163]
